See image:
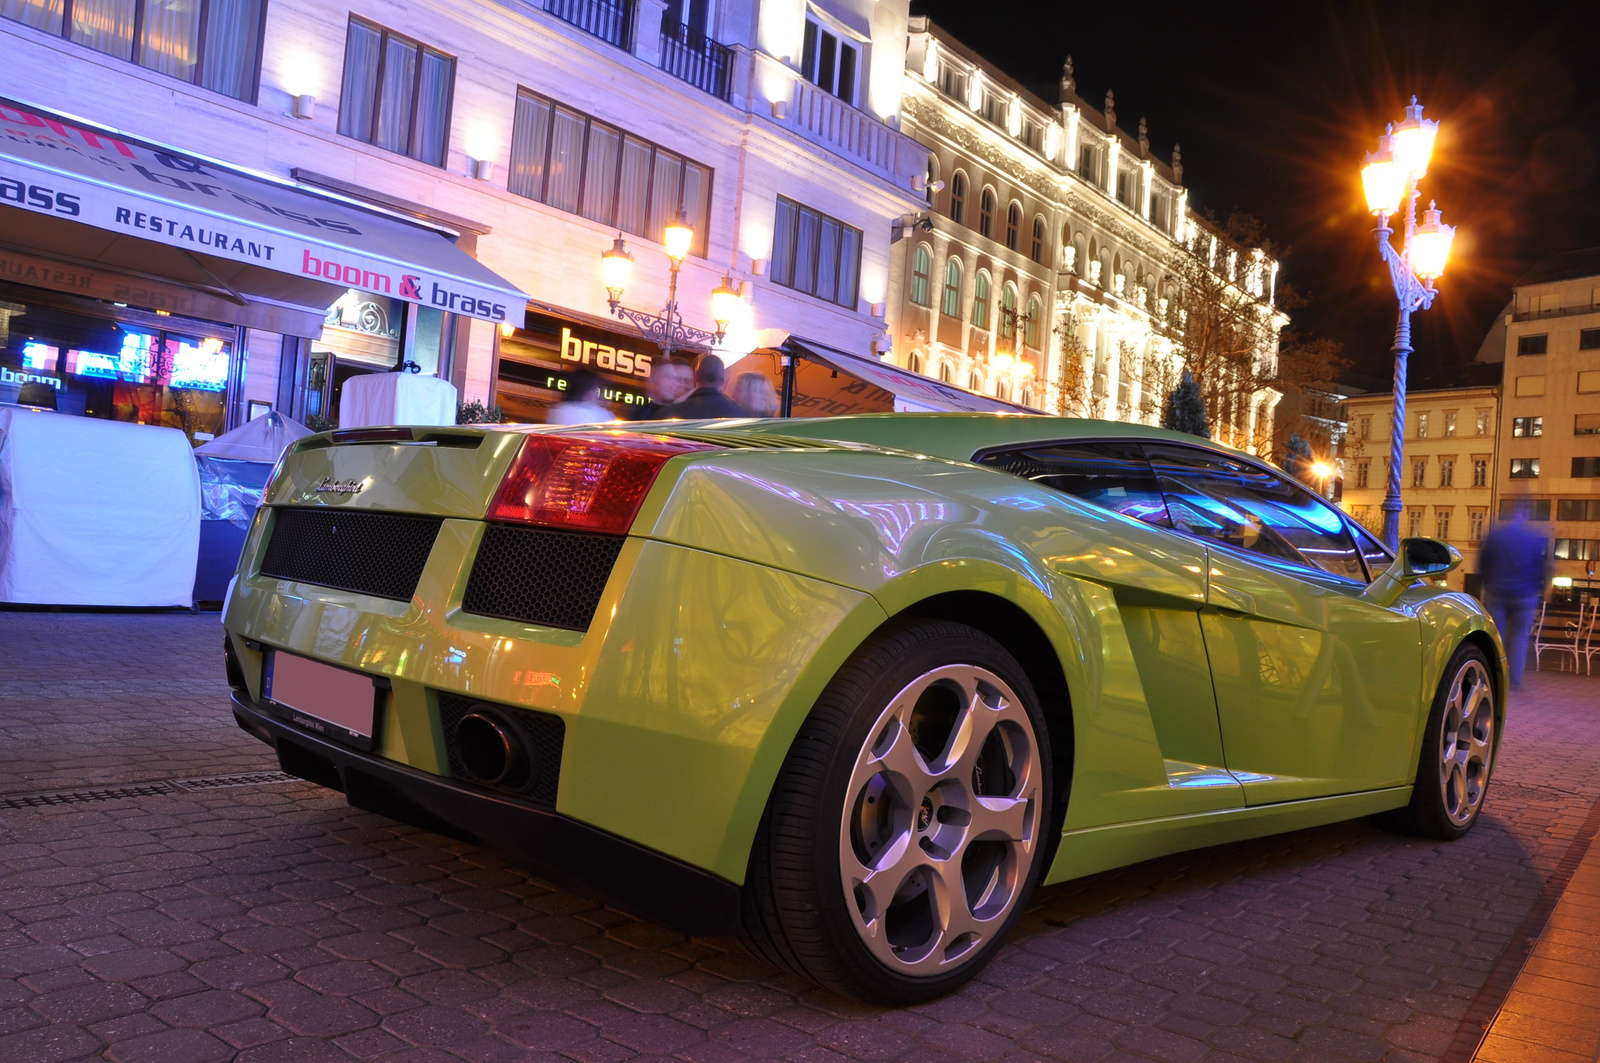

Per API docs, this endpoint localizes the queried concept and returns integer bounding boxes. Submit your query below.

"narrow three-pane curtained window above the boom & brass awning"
[339,16,454,166]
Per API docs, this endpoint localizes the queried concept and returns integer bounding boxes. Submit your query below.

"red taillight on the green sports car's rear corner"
[488,435,720,535]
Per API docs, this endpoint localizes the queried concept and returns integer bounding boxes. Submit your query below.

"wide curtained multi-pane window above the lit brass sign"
[506,90,712,256]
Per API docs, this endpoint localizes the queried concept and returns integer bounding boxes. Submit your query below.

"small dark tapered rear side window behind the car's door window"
[978,442,1171,528]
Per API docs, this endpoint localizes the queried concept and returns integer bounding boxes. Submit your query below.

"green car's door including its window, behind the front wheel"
[1144,443,1422,805]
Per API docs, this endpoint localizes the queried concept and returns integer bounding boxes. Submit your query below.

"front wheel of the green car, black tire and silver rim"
[1378,642,1501,842]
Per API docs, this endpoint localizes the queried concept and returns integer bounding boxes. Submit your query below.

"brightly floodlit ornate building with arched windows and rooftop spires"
[891,18,1286,450]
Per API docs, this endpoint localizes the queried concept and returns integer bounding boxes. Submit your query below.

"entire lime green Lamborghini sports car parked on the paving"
[222,415,1506,1002]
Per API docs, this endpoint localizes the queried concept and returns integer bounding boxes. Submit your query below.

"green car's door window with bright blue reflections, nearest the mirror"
[1144,443,1366,583]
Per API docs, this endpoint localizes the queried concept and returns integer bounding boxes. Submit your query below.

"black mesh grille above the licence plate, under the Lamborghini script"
[261,507,442,602]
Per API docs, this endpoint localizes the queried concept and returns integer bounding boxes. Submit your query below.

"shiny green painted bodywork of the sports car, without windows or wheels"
[224,415,1504,882]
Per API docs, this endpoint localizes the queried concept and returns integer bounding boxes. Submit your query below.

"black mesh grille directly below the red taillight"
[461,523,626,631]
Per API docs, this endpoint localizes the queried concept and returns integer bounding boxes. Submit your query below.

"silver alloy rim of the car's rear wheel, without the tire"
[838,664,1043,975]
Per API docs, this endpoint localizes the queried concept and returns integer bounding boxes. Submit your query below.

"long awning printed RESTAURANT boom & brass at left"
[0,99,526,332]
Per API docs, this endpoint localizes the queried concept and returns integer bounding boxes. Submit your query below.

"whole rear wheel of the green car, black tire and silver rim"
[742,621,1051,1005]
